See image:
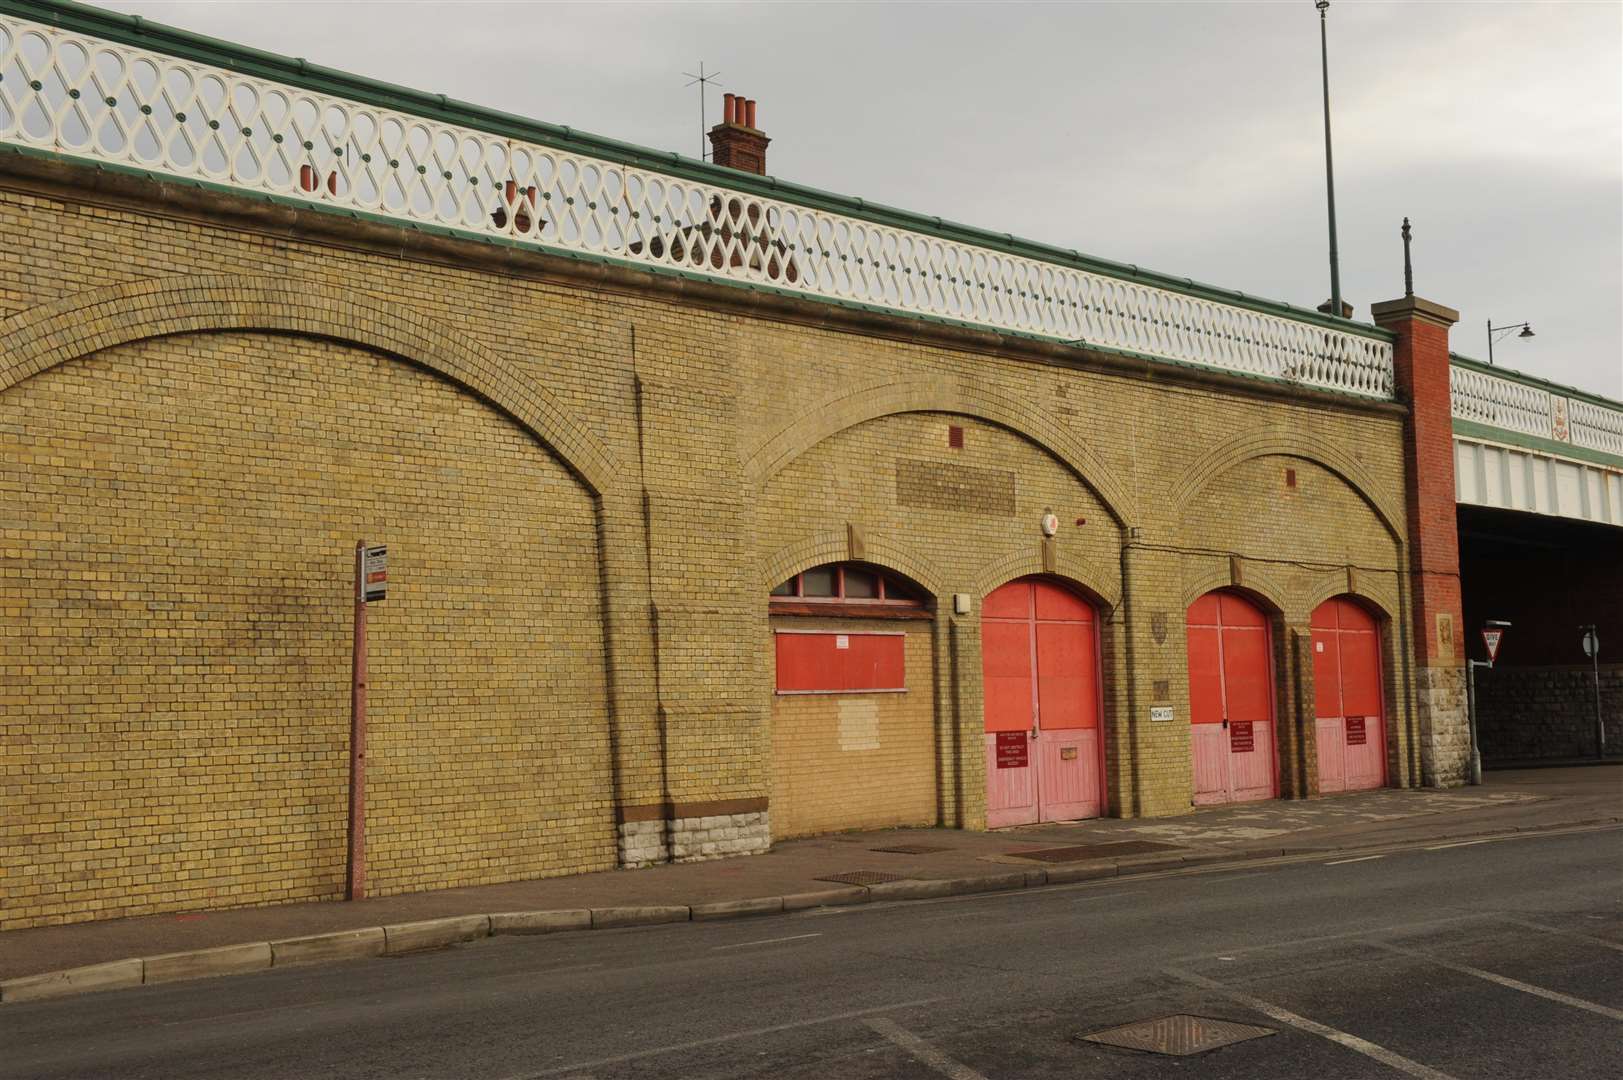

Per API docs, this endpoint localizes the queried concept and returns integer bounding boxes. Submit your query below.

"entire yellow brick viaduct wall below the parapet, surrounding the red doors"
[0,162,1412,926]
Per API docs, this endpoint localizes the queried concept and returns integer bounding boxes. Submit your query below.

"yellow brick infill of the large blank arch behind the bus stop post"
[0,333,613,927]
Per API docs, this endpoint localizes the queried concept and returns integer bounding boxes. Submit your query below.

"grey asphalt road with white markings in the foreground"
[0,828,1623,1080]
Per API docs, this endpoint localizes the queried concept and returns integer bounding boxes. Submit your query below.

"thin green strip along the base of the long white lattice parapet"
[0,143,1393,406]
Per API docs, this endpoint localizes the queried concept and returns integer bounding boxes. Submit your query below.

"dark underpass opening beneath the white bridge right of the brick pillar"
[1457,505,1623,768]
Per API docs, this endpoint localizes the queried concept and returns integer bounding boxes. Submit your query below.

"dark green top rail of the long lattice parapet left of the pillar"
[0,0,1394,341]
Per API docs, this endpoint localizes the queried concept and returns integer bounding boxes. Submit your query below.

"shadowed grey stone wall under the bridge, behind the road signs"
[1477,664,1623,765]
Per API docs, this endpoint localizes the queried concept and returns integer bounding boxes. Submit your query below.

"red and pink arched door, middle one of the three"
[1186,590,1279,806]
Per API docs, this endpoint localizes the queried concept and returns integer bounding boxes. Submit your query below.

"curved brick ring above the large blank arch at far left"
[0,274,617,495]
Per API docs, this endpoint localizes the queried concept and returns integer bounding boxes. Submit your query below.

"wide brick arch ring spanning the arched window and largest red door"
[743,378,1138,529]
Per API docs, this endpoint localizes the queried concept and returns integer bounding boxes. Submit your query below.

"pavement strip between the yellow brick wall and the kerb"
[0,765,1623,983]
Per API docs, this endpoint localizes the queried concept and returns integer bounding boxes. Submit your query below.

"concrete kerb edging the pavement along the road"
[0,817,1623,1004]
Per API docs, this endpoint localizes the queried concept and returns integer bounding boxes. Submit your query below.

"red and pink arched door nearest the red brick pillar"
[1313,596,1386,793]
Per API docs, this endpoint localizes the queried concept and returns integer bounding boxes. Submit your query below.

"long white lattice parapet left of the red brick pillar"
[0,2,1393,400]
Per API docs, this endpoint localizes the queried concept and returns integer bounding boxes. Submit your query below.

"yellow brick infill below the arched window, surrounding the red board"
[768,617,936,840]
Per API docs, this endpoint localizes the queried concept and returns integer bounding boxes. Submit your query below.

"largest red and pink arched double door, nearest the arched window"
[980,578,1104,828]
